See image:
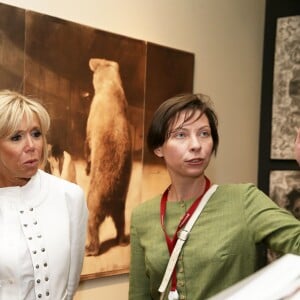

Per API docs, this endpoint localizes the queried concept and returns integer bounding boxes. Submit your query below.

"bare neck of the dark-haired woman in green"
[168,176,206,201]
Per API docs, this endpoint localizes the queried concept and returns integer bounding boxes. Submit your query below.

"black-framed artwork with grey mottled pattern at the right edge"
[258,0,300,195]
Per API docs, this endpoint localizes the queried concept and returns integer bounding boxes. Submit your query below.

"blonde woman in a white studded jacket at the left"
[0,90,87,300]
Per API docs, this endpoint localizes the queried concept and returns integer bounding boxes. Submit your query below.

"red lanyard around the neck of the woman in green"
[160,177,211,291]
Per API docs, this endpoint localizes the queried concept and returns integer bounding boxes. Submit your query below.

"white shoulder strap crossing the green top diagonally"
[158,184,218,293]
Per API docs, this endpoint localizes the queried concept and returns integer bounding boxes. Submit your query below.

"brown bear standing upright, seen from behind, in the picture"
[85,58,132,256]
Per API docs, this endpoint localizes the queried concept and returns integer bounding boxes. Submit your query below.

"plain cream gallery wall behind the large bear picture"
[2,0,265,300]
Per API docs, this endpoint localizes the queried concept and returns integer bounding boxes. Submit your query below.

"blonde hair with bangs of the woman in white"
[0,90,50,167]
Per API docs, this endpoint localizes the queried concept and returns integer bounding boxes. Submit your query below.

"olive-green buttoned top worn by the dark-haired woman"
[129,184,300,300]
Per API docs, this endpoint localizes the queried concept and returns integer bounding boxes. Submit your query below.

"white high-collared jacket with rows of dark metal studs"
[0,170,87,300]
